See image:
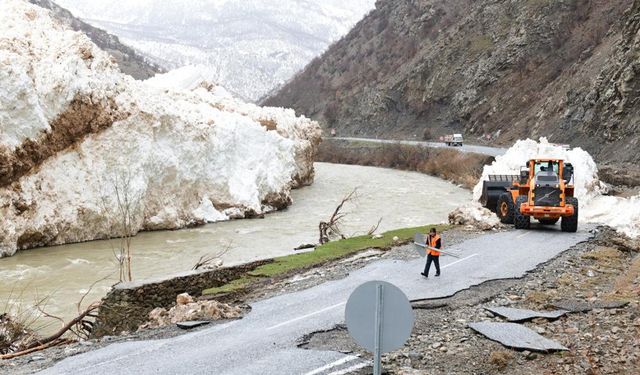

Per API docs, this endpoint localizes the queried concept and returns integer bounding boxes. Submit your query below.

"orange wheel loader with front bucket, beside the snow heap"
[480,159,578,232]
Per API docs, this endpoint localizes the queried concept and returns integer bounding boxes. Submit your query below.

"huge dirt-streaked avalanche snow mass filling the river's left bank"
[0,0,320,256]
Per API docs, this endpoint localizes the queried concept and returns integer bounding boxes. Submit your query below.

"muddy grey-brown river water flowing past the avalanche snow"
[0,163,471,331]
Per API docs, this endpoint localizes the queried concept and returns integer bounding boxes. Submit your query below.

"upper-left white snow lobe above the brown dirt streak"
[0,1,120,151]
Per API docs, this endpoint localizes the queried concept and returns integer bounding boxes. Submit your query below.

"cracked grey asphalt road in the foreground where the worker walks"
[43,225,591,375]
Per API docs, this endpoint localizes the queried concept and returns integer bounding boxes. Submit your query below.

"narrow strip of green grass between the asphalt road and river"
[202,224,451,295]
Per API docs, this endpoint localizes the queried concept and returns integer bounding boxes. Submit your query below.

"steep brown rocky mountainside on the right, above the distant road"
[262,0,640,162]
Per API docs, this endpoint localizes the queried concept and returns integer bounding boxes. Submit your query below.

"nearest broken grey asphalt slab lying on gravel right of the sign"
[469,322,569,352]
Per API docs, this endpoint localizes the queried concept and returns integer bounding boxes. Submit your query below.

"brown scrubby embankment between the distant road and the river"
[316,139,494,189]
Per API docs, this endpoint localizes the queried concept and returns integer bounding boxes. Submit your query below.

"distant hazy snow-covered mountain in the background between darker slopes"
[56,0,375,101]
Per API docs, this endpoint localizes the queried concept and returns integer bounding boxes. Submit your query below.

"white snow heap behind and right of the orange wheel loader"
[473,138,640,237]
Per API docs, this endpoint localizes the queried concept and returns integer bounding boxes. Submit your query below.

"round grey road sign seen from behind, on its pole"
[345,281,414,375]
